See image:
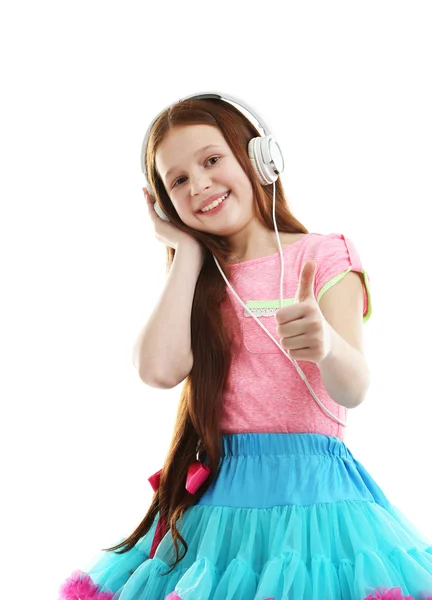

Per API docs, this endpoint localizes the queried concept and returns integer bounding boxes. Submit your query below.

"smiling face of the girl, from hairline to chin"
[155,125,254,236]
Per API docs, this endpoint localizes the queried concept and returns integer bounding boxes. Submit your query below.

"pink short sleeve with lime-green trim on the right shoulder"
[314,233,372,323]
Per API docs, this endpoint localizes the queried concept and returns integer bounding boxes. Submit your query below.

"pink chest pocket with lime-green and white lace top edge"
[242,298,295,354]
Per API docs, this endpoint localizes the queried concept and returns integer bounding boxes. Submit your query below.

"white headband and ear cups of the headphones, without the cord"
[141,92,285,221]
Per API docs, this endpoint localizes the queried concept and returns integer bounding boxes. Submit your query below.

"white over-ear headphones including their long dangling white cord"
[141,92,348,427]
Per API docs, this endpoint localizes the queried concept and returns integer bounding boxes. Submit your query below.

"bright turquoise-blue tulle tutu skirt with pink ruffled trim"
[60,433,432,600]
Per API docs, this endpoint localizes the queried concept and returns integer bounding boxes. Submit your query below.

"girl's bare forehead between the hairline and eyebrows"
[155,125,228,181]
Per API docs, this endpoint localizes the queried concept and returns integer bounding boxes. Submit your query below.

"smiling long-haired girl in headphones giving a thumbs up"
[60,94,432,600]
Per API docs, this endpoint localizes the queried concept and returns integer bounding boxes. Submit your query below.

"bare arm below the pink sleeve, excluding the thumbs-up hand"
[317,271,370,408]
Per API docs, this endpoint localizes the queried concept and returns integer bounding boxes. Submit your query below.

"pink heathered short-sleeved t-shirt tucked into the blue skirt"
[221,233,372,440]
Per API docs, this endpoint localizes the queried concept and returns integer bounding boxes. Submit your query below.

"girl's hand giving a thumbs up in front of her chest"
[275,260,333,364]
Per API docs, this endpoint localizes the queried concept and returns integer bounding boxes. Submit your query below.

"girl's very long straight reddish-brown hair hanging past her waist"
[104,99,308,575]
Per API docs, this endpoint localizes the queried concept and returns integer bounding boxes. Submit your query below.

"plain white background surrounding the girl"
[0,0,432,600]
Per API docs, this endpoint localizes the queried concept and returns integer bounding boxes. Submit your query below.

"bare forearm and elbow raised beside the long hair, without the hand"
[133,244,204,388]
